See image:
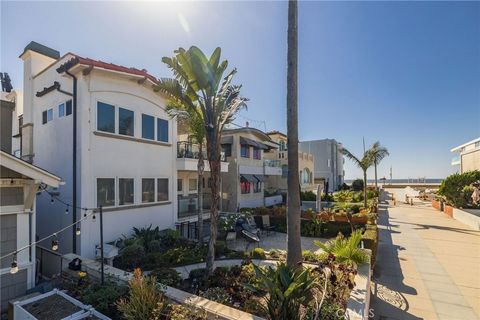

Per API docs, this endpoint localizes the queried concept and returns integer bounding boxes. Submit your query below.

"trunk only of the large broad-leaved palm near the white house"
[206,127,221,275]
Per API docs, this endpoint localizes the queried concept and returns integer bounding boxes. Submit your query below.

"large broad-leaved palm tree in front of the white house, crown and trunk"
[154,46,247,274]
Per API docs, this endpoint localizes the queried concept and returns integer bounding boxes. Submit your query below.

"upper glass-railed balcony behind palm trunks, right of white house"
[177,141,228,172]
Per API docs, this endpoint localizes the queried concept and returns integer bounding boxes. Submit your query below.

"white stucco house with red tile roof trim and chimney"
[20,42,177,258]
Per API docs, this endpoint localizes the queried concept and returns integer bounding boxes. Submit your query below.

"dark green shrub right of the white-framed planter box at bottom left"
[81,281,128,319]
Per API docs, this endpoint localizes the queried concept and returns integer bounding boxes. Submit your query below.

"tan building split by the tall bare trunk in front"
[265,131,315,194]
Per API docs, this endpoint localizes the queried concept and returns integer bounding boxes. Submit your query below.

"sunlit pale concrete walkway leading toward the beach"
[371,199,480,320]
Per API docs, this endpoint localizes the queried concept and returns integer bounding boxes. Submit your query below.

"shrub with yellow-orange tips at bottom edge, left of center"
[117,269,167,320]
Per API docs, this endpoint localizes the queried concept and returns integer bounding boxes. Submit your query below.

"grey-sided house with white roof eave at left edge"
[0,151,60,312]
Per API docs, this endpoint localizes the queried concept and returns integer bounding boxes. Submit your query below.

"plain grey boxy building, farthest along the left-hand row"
[300,139,345,192]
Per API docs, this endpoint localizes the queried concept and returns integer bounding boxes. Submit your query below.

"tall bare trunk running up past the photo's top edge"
[287,0,302,266]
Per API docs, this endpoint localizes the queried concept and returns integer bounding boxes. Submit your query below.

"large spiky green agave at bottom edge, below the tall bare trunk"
[244,263,319,320]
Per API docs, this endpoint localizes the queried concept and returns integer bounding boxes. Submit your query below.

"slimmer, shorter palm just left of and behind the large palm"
[166,106,205,246]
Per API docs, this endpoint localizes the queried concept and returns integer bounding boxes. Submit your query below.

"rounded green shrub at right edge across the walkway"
[438,170,480,208]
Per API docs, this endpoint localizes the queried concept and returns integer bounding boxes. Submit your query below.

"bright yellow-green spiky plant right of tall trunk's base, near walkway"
[315,230,368,266]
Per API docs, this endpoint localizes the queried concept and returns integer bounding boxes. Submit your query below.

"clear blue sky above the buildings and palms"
[0,1,480,178]
